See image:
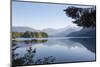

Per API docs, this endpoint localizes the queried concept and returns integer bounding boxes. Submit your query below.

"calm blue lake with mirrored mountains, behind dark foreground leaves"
[12,37,96,64]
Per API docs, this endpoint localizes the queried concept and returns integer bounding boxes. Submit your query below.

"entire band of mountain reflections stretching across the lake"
[13,38,96,53]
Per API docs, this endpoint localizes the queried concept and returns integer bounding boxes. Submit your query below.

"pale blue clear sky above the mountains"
[12,1,92,30]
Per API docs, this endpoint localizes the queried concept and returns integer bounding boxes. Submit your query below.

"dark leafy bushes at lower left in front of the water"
[12,44,55,66]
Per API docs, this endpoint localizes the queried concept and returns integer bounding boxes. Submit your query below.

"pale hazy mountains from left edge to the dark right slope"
[12,27,79,37]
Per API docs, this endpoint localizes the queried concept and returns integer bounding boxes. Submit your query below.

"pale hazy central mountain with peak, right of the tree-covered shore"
[42,27,77,37]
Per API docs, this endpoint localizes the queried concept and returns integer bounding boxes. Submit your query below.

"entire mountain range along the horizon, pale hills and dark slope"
[12,27,96,37]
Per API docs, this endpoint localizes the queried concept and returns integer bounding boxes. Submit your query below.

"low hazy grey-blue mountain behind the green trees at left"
[12,27,39,32]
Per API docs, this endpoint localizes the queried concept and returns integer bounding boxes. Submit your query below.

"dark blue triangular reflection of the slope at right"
[70,38,96,53]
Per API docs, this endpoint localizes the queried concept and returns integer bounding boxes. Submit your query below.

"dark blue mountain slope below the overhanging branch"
[67,27,96,37]
